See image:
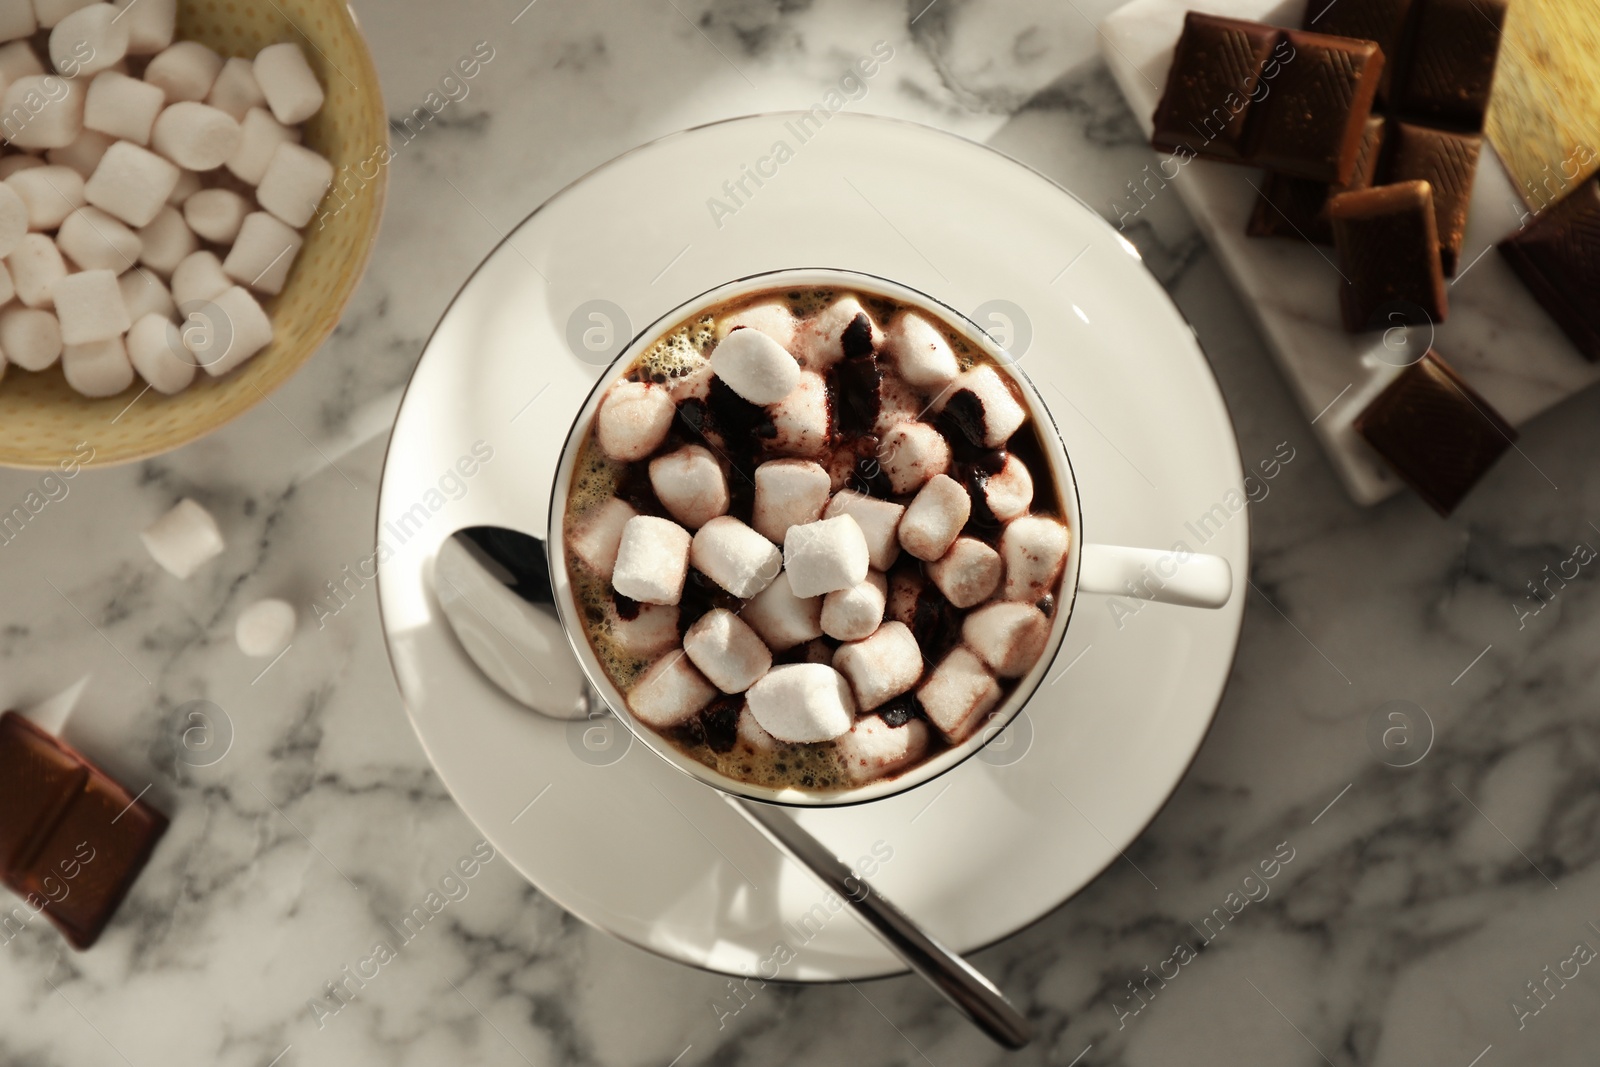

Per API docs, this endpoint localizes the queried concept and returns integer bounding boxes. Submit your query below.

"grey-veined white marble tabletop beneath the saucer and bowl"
[0,0,1600,1067]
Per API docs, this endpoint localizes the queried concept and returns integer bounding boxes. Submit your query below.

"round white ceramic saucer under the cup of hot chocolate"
[378,114,1250,981]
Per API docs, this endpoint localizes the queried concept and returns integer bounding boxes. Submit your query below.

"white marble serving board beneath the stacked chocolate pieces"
[1099,0,1600,504]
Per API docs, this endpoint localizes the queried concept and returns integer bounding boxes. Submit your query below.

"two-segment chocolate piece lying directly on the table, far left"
[0,712,166,949]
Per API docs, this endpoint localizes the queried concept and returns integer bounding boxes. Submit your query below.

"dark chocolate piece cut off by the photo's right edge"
[1499,178,1600,362]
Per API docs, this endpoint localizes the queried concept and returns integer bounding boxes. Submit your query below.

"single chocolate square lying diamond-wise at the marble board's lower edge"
[1355,350,1517,515]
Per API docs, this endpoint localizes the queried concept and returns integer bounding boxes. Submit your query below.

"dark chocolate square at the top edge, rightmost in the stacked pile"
[1395,0,1507,130]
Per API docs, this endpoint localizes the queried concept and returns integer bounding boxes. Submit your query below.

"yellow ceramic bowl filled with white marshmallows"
[0,0,387,467]
